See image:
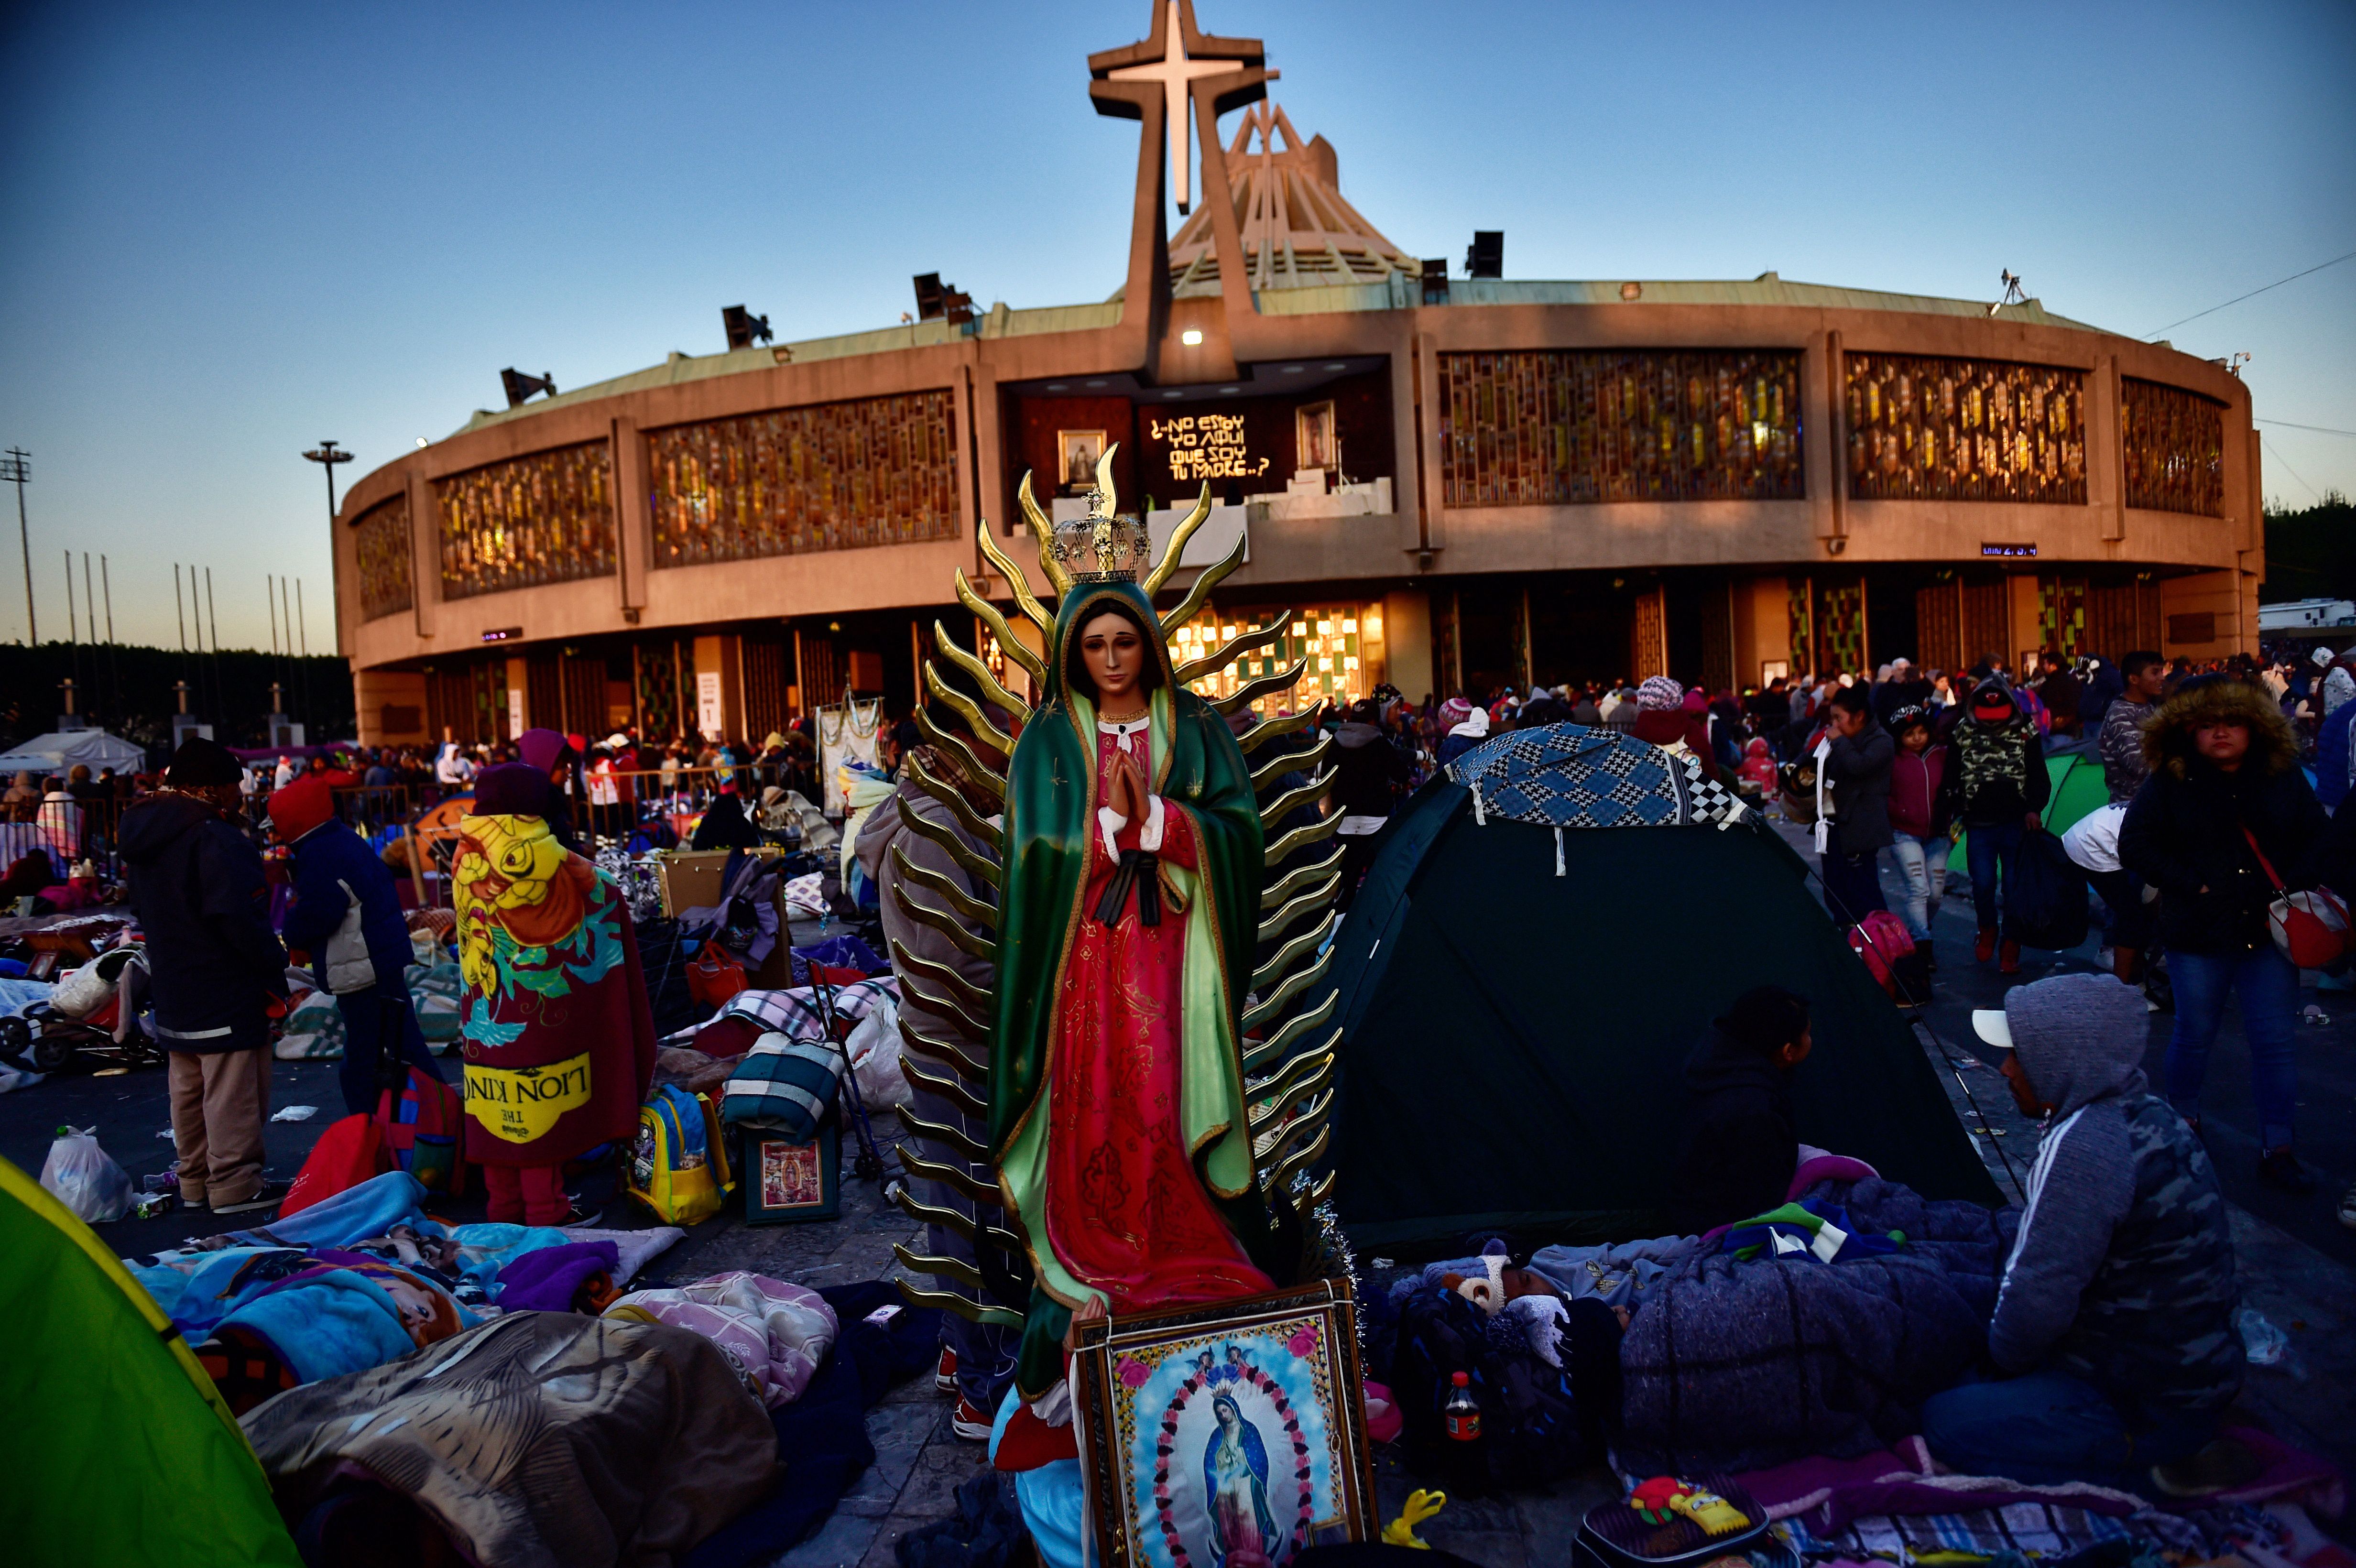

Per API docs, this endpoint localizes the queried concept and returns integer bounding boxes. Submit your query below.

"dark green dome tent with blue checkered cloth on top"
[1333,725,2000,1252]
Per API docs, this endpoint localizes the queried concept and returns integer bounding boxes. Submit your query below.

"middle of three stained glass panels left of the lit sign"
[434,440,615,598]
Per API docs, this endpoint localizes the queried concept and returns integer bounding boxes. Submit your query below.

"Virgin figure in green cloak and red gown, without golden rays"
[990,544,1275,1396]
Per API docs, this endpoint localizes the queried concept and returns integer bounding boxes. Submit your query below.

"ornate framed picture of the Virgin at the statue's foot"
[1074,1281,1374,1568]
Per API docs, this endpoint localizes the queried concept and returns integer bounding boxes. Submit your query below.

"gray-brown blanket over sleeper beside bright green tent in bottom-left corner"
[243,1311,777,1568]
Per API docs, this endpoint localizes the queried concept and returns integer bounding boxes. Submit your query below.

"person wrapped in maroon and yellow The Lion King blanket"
[450,763,655,1224]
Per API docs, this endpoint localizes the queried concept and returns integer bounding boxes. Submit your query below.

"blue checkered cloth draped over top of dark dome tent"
[1449,725,1751,829]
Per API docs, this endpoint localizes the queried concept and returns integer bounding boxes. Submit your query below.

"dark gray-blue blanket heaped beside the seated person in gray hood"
[1619,1182,2014,1474]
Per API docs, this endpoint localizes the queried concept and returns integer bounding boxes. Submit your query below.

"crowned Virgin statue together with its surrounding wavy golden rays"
[867,447,1345,1412]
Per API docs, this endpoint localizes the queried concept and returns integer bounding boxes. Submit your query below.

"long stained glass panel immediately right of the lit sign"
[1440,348,1807,506]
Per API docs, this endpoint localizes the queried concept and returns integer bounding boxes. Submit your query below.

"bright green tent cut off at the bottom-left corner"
[0,1158,302,1568]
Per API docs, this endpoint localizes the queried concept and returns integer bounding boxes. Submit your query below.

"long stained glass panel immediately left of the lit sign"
[645,391,959,567]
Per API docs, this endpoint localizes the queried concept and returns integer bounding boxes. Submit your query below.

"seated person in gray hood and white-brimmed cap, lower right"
[1922,975,2243,1495]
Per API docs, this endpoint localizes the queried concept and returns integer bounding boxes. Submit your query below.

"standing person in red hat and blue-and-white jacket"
[271,774,441,1116]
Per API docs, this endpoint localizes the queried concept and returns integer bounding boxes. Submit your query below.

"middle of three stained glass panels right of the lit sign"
[1847,353,2085,506]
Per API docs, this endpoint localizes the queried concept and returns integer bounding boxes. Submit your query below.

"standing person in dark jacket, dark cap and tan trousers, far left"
[118,737,287,1215]
